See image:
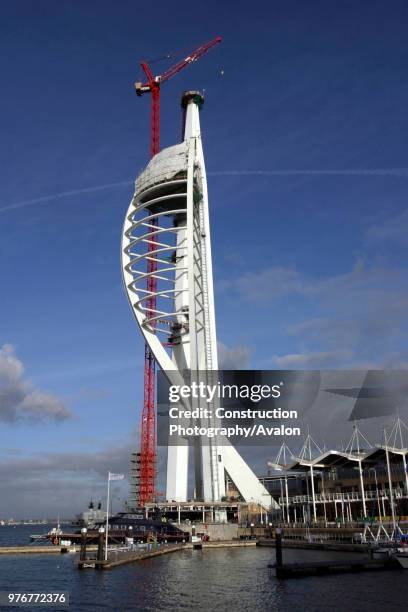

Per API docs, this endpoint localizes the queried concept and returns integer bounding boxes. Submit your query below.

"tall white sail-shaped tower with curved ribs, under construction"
[122,92,272,507]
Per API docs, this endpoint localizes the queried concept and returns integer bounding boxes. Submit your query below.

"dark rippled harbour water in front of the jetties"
[0,526,408,612]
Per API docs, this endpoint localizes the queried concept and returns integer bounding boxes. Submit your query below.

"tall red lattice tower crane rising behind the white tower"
[135,36,221,506]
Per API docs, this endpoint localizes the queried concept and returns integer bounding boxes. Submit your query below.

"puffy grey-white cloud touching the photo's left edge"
[0,344,72,423]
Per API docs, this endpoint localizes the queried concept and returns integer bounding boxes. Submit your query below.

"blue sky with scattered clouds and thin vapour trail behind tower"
[0,0,408,516]
